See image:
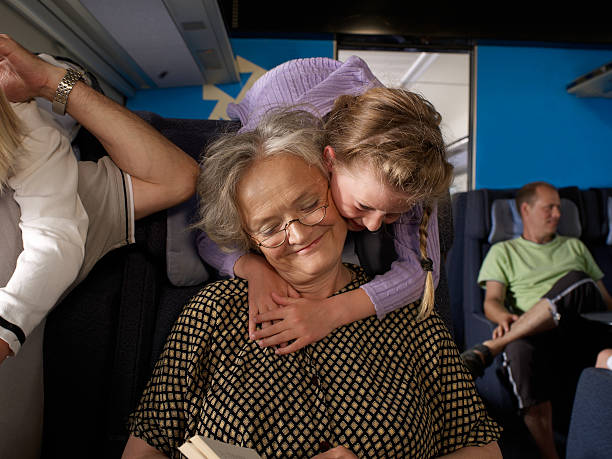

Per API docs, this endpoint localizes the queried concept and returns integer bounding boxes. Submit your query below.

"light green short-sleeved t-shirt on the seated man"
[478,236,603,311]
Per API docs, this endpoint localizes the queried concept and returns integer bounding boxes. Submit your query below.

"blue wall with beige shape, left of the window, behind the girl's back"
[126,38,334,119]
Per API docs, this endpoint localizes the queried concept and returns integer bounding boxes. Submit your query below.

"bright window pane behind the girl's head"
[338,47,471,194]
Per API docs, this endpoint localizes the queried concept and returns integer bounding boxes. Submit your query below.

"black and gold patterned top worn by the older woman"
[129,266,500,458]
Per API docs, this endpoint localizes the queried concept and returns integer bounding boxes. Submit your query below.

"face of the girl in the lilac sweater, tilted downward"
[325,147,410,231]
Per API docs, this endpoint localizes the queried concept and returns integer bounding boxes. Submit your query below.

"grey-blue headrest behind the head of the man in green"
[488,198,584,244]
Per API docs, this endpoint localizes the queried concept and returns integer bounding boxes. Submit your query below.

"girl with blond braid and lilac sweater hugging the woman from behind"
[198,56,452,353]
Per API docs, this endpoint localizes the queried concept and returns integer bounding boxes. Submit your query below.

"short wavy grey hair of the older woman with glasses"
[194,108,327,251]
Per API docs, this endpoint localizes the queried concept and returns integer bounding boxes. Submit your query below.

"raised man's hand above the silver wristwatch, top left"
[0,34,59,102]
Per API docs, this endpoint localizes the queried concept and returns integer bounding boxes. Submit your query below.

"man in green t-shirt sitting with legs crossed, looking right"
[462,182,612,458]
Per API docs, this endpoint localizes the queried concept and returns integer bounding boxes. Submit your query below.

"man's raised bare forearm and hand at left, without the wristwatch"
[0,34,199,219]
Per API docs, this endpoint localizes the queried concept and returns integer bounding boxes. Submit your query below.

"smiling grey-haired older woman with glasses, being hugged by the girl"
[124,111,500,458]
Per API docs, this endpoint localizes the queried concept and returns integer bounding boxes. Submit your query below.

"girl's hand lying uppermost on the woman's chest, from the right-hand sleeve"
[254,293,342,354]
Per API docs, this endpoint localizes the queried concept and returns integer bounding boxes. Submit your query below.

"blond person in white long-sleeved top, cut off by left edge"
[0,91,88,362]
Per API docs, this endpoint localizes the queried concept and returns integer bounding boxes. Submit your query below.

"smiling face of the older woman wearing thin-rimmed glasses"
[237,155,346,286]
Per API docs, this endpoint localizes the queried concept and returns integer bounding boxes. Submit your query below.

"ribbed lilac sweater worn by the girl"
[197,56,440,318]
